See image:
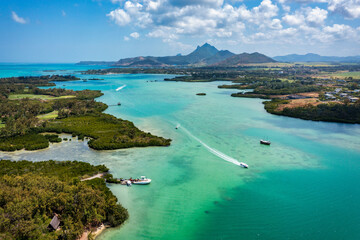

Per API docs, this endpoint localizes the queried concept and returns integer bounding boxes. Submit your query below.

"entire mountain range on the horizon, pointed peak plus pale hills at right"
[77,43,360,67]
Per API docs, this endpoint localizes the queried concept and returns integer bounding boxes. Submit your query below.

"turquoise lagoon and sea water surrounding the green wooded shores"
[0,65,360,240]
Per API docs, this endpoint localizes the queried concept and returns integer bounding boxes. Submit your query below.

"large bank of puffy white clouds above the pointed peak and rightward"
[107,0,360,49]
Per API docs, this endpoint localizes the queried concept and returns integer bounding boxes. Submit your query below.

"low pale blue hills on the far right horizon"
[273,53,360,62]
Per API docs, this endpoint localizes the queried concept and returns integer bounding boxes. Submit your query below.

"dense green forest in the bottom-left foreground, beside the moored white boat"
[0,160,128,240]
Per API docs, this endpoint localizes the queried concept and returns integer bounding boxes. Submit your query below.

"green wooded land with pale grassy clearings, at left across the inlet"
[0,75,171,151]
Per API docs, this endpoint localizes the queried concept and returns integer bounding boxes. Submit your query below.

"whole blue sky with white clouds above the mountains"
[0,0,360,62]
